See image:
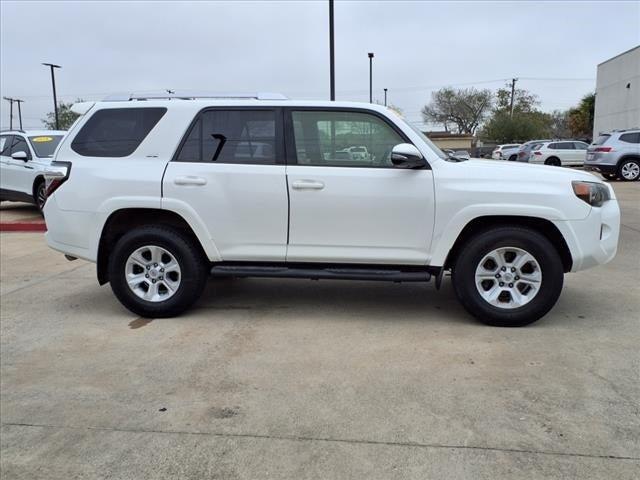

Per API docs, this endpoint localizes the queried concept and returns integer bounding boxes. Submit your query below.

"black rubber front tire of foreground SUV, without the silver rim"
[452,227,564,327]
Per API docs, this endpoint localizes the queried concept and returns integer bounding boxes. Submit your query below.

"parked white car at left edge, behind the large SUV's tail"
[0,130,67,209]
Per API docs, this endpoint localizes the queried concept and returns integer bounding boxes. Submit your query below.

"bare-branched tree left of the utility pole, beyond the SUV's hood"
[422,87,493,135]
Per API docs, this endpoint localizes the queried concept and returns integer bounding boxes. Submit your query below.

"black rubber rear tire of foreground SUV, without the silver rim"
[109,226,209,318]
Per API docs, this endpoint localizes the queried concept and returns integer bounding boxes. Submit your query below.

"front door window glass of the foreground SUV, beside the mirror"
[292,111,405,167]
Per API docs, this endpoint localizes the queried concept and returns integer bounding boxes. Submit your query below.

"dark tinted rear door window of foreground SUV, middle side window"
[177,110,276,164]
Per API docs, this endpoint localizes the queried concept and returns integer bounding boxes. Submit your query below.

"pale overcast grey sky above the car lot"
[0,0,640,129]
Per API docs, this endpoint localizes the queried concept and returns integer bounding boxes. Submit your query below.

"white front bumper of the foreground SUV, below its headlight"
[554,198,620,272]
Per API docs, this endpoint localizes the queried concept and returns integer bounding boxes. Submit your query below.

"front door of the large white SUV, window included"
[286,109,434,265]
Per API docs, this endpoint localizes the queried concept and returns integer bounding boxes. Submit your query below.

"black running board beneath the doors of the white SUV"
[211,265,431,282]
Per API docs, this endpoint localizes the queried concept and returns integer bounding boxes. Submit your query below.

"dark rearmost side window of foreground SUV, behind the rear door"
[71,108,167,157]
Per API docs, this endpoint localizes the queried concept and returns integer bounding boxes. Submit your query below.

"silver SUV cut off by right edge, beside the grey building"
[584,128,640,182]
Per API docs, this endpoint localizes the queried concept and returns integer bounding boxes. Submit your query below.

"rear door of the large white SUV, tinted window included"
[163,107,288,262]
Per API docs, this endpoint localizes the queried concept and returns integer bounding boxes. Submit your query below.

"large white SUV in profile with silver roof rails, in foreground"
[44,94,620,326]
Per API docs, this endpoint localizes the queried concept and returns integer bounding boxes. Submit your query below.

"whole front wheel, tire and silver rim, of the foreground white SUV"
[452,227,564,327]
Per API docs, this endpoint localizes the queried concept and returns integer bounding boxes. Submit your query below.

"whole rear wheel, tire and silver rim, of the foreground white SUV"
[109,226,208,318]
